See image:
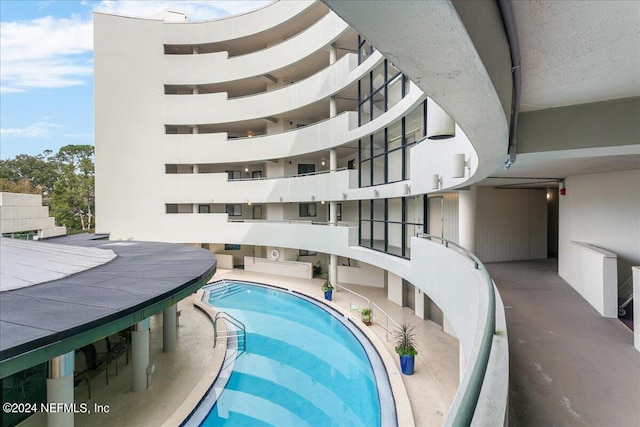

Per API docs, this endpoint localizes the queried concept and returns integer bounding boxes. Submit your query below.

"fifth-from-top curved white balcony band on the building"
[162,169,358,203]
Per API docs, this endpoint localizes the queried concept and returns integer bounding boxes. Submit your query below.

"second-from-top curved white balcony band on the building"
[162,11,349,85]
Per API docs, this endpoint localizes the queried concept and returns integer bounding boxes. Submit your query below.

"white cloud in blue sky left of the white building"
[0,16,93,93]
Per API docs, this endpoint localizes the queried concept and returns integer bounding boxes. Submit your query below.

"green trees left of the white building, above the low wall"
[0,145,95,233]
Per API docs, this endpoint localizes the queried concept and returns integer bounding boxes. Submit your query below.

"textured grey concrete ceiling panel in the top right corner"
[512,0,640,111]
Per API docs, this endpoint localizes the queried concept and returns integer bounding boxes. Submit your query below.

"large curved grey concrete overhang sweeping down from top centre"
[323,0,511,183]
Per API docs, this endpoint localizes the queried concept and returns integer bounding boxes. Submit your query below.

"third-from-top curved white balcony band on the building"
[164,54,362,125]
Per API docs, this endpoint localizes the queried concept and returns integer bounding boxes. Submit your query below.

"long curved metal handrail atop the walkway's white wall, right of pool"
[416,233,496,426]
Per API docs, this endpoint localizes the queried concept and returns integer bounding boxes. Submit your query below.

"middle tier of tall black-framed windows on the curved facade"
[359,101,426,187]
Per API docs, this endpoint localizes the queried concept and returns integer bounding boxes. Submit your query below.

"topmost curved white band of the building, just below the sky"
[164,0,317,45]
